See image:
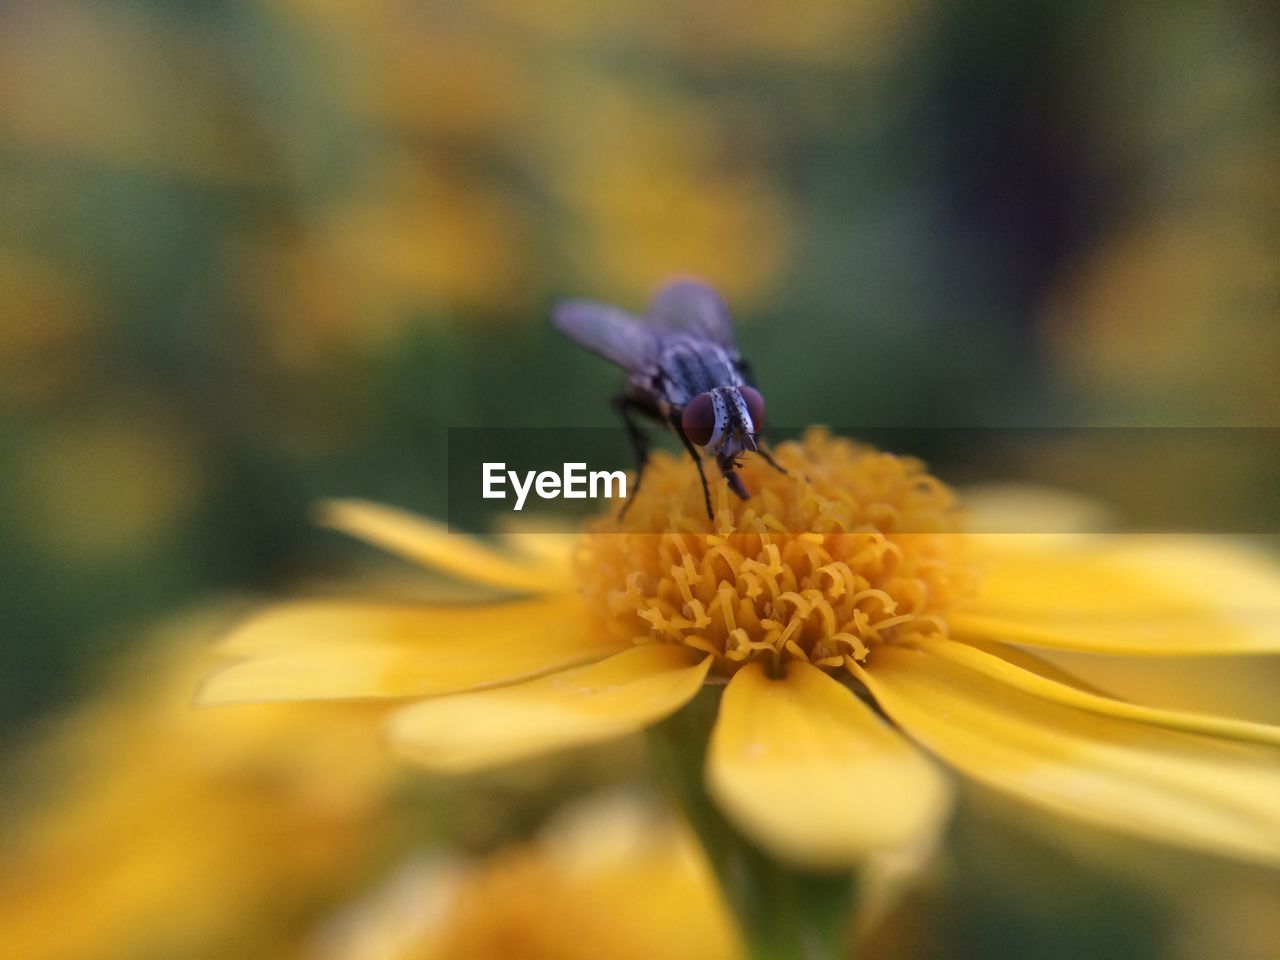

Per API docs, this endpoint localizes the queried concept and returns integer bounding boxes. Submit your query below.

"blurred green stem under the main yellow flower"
[649,685,858,960]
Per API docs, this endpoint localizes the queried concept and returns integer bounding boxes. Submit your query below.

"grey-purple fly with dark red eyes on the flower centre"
[553,280,786,517]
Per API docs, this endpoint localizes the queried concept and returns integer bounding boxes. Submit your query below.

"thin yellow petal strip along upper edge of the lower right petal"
[913,639,1280,746]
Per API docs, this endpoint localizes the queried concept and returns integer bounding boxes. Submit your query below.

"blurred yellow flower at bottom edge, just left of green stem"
[316,796,739,960]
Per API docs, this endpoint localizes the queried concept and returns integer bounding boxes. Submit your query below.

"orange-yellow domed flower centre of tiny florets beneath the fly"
[575,430,975,676]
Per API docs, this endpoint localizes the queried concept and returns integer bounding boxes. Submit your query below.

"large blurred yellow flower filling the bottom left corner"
[0,624,403,960]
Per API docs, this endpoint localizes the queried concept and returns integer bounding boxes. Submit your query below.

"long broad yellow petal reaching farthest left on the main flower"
[200,598,618,703]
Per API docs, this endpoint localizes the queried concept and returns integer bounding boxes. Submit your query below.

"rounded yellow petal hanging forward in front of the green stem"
[707,662,948,868]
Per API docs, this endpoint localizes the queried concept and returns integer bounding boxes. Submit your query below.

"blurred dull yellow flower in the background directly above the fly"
[538,82,795,302]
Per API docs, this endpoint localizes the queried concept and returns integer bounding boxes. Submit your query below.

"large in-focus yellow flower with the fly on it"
[204,431,1280,868]
